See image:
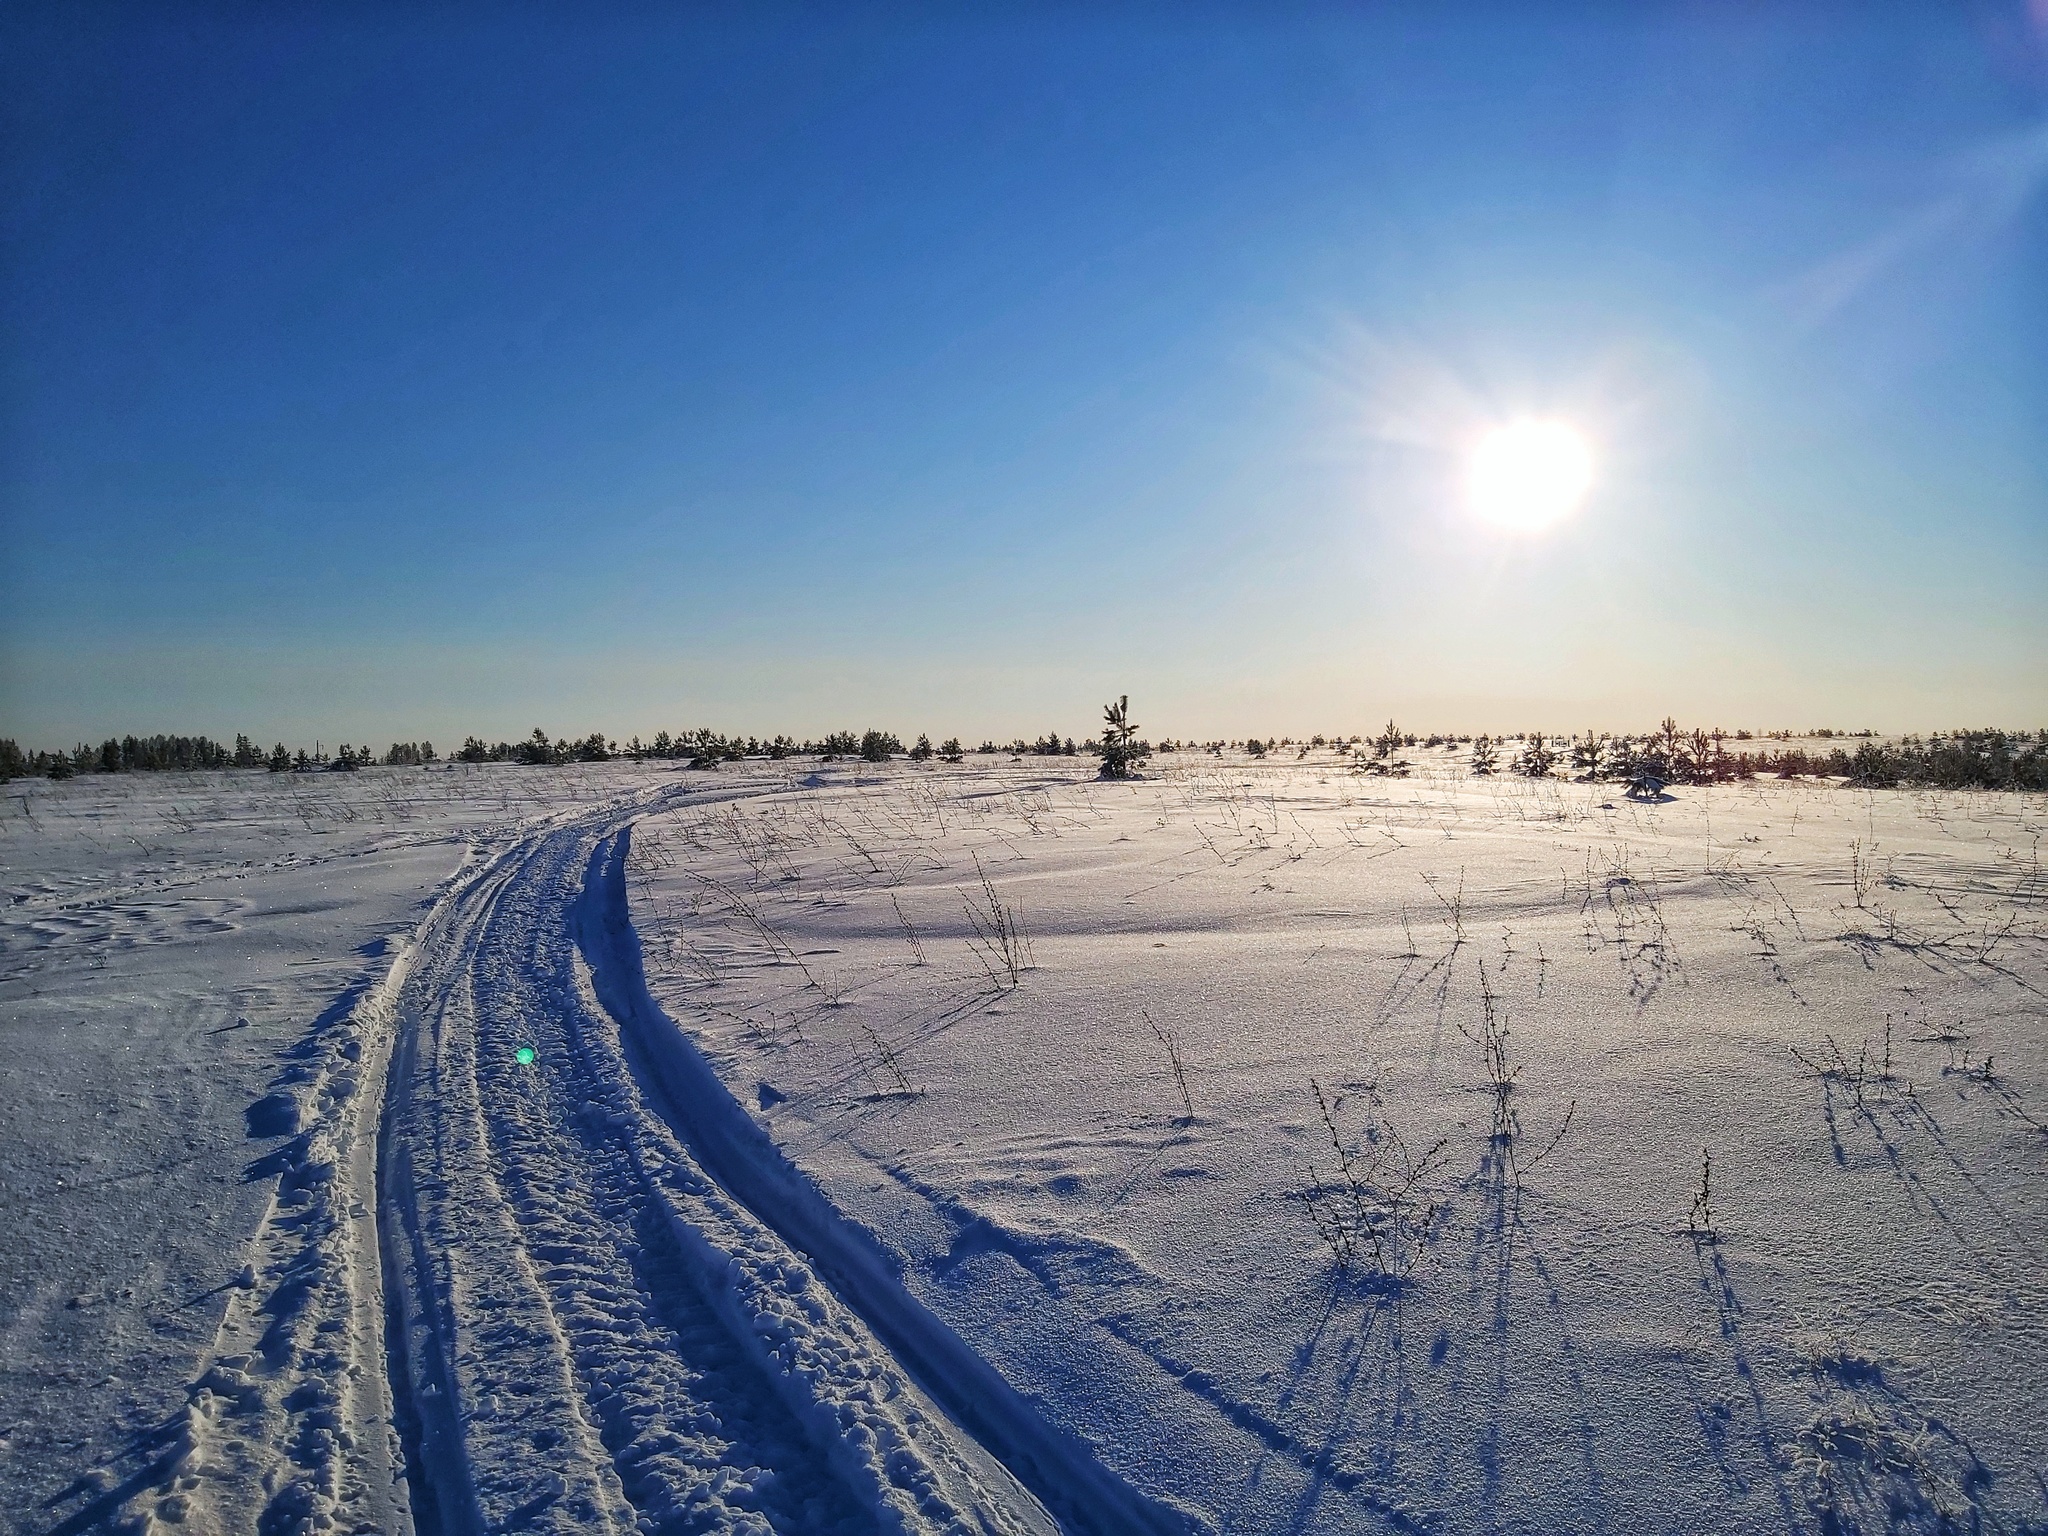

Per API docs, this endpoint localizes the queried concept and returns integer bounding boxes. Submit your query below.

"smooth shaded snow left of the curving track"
[0,774,540,1530]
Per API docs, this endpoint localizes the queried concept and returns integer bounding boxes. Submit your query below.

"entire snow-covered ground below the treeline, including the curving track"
[0,754,2048,1534]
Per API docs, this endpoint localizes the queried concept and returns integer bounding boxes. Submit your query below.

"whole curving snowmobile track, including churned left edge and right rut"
[127,786,1190,1536]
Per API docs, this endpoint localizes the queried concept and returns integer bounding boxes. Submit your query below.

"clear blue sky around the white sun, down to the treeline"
[0,0,2048,745]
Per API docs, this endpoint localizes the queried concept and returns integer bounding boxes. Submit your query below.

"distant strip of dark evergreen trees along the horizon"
[0,721,2048,791]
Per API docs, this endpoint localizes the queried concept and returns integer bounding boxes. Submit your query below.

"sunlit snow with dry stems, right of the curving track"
[633,754,2048,1532]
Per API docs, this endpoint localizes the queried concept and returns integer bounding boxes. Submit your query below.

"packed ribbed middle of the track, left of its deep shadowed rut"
[381,813,1051,1534]
